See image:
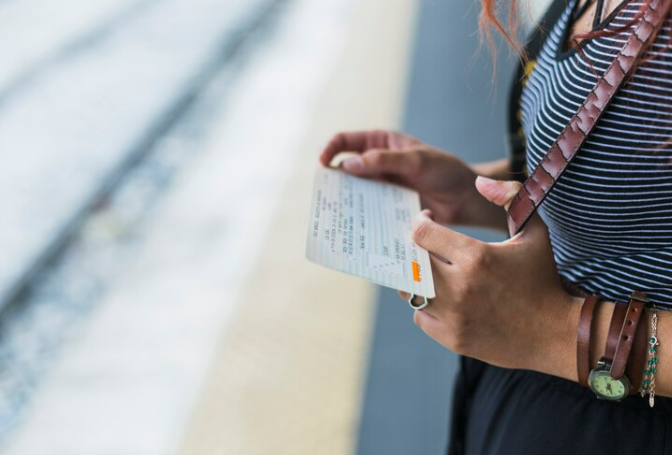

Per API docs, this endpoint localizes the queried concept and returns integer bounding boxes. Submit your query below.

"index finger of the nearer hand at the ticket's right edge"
[412,210,480,263]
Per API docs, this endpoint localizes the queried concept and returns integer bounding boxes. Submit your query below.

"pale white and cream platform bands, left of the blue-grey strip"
[2,0,415,455]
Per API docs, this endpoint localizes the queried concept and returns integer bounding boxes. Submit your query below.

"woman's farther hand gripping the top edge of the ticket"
[320,131,506,230]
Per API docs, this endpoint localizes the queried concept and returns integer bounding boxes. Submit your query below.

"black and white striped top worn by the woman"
[521,0,672,309]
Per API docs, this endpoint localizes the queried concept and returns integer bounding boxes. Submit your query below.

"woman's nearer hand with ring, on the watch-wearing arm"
[400,178,581,380]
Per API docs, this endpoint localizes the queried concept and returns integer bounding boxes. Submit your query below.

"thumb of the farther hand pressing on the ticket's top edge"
[343,149,419,177]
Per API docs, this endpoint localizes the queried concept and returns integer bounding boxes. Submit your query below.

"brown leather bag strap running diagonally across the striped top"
[508,0,672,236]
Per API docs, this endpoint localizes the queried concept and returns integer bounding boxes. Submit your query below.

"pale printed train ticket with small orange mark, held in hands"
[306,168,435,298]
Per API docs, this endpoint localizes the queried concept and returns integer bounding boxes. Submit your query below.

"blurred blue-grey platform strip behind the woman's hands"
[358,0,512,455]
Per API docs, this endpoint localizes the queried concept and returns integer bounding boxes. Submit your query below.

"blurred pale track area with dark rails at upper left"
[0,0,278,306]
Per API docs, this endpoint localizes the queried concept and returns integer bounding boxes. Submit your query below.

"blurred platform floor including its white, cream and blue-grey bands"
[0,0,536,455]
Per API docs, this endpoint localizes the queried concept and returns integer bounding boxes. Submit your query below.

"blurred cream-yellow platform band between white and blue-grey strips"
[179,0,416,455]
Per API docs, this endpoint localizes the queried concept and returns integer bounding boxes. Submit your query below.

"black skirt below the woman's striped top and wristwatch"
[448,357,672,455]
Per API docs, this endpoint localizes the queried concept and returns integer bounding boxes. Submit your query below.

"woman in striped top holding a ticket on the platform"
[320,0,672,455]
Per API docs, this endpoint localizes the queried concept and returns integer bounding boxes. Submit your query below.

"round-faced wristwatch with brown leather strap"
[588,292,648,401]
